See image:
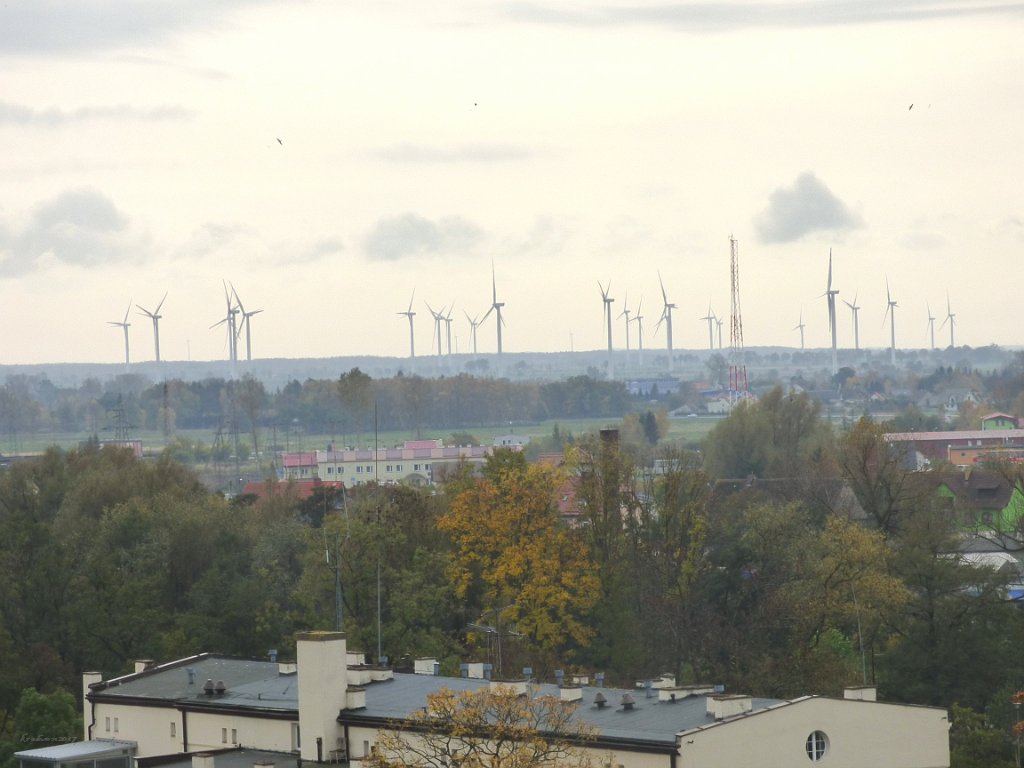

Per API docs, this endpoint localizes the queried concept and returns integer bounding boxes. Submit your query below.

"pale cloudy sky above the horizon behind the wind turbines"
[0,0,1024,364]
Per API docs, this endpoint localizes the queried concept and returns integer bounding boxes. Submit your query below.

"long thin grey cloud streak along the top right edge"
[504,0,1024,32]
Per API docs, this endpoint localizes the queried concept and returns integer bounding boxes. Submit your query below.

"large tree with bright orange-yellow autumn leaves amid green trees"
[438,461,599,666]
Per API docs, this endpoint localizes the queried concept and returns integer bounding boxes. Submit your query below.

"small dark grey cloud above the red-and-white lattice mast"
[756,173,863,243]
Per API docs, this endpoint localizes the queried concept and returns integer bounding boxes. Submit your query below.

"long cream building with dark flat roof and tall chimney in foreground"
[74,632,949,768]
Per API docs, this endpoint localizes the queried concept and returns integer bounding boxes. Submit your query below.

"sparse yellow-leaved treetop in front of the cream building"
[367,686,595,768]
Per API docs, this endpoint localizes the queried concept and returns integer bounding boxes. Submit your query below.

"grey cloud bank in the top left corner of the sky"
[0,0,263,54]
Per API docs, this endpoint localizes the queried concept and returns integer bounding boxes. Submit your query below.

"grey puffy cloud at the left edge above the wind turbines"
[0,189,140,276]
